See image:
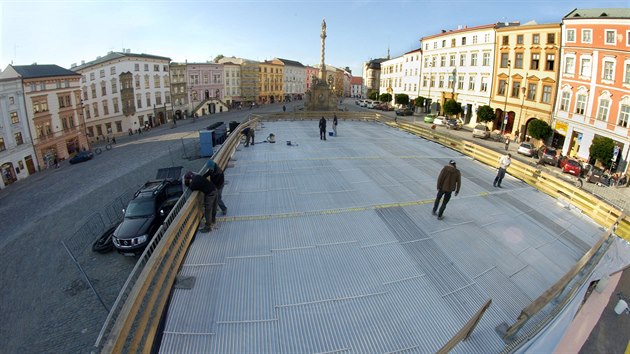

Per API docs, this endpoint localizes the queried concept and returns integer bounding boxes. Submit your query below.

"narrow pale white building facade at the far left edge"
[0,74,39,188]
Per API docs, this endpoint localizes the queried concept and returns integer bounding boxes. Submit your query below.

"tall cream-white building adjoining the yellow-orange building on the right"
[420,24,496,126]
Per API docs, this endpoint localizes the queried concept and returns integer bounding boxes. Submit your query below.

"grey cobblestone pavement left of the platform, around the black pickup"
[0,105,282,353]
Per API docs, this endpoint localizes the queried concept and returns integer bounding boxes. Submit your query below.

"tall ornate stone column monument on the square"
[304,19,337,111]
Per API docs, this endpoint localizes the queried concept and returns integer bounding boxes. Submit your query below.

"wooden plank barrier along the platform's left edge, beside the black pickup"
[95,119,258,353]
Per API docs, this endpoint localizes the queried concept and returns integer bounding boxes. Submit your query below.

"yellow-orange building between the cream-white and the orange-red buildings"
[490,22,561,140]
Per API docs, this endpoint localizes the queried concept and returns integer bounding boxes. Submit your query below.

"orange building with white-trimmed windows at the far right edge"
[552,9,630,172]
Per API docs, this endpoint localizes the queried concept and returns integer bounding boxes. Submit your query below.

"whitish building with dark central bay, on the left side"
[71,50,173,141]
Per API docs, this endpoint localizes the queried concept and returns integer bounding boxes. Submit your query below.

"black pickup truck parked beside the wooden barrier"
[112,179,183,256]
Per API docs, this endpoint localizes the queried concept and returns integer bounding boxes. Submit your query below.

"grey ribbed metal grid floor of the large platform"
[160,121,601,353]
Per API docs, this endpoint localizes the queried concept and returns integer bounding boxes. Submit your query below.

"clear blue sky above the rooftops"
[0,0,630,76]
